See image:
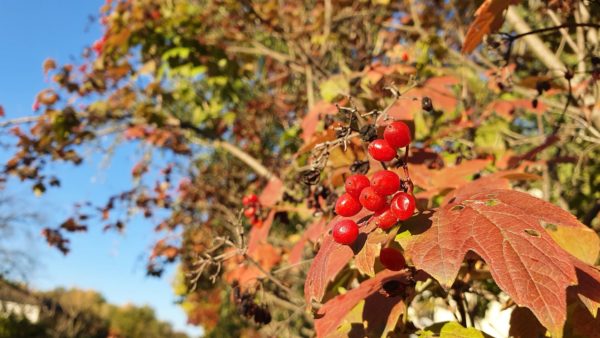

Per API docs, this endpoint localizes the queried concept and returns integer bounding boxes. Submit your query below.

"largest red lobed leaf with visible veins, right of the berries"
[399,190,585,336]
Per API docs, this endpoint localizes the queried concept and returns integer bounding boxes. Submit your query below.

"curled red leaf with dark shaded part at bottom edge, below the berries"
[315,270,407,337]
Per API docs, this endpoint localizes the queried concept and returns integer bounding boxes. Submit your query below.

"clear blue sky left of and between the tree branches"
[0,0,201,335]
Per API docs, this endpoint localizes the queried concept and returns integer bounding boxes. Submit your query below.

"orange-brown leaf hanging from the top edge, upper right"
[462,0,519,53]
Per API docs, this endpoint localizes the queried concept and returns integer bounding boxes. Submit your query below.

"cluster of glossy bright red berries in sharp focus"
[333,122,415,245]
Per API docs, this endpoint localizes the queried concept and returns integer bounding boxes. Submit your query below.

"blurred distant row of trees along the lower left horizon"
[0,280,187,338]
